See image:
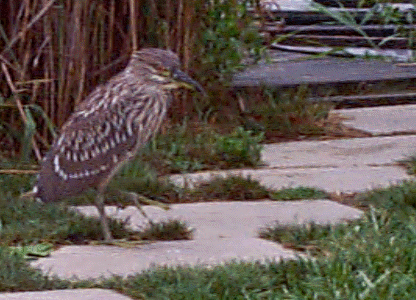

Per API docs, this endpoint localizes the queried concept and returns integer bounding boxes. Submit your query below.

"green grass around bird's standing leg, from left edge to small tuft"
[0,175,190,246]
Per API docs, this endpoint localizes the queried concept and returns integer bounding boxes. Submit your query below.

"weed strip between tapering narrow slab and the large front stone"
[70,171,329,206]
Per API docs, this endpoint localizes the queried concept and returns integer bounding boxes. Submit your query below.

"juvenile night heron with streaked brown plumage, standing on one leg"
[33,48,203,241]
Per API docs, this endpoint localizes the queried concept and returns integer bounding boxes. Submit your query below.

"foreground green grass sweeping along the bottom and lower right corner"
[0,182,416,299]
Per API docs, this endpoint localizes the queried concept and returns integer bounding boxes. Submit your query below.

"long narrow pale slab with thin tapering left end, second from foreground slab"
[172,166,413,193]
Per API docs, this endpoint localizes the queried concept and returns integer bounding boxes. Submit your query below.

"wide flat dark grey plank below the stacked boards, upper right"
[232,57,416,88]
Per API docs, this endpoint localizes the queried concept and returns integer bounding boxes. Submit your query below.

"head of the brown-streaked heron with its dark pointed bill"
[130,48,205,94]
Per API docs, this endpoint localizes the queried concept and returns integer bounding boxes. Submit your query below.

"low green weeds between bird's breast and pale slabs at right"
[133,126,263,174]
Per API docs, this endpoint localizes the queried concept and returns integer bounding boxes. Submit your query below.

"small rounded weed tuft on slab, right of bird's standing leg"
[139,220,193,241]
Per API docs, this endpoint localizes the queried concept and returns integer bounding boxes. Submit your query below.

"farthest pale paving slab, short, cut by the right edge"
[334,104,416,135]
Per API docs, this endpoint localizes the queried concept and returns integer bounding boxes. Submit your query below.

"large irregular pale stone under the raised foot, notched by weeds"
[32,200,362,279]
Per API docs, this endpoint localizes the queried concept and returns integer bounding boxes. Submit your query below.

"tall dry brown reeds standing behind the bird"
[0,0,260,162]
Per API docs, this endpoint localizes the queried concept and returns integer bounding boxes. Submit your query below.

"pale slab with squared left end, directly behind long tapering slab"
[262,135,416,169]
